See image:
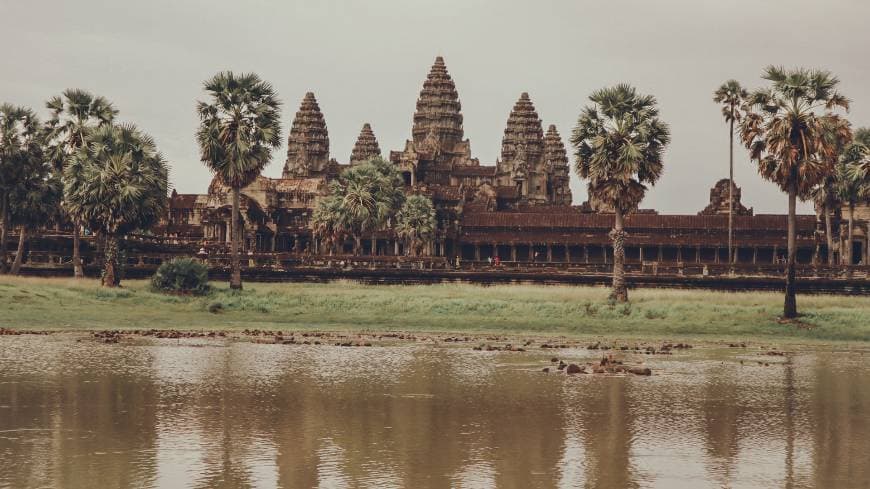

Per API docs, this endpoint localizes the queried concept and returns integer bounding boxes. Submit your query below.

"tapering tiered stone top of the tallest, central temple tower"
[412,56,464,151]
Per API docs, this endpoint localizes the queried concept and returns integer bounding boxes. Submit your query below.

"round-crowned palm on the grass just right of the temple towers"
[571,84,670,302]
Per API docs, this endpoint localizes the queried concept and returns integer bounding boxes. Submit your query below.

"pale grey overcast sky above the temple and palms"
[0,0,870,213]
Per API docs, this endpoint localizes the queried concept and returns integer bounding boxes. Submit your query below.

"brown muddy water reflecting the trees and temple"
[0,335,870,488]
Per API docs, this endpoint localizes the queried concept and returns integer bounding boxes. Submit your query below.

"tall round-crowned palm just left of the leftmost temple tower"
[196,71,281,289]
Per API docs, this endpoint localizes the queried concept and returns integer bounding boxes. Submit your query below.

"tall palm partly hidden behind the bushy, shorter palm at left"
[45,88,118,278]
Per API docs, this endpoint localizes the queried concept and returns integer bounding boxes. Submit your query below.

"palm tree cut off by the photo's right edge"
[835,128,870,265]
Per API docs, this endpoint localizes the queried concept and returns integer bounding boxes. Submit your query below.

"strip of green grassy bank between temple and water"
[0,277,870,341]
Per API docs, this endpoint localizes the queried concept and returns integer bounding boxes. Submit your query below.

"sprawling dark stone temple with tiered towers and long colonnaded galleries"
[155,57,870,264]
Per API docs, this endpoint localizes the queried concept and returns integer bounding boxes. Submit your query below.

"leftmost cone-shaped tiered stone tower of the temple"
[283,92,330,178]
